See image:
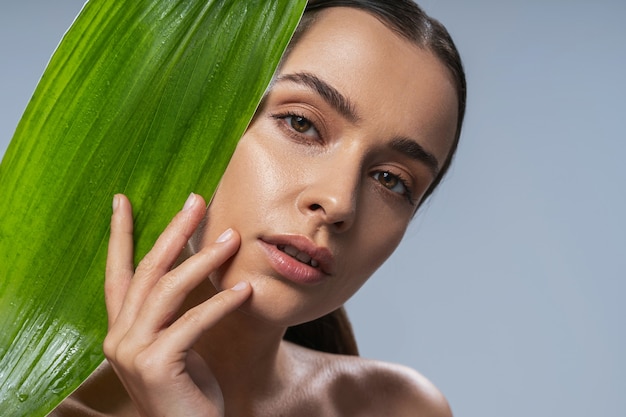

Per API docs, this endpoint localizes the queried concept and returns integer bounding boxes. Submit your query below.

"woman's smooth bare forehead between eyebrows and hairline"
[277,7,457,159]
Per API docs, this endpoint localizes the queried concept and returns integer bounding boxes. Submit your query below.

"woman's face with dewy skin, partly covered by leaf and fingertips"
[197,8,457,325]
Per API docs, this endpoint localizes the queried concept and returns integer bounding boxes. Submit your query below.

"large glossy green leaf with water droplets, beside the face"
[0,0,305,416]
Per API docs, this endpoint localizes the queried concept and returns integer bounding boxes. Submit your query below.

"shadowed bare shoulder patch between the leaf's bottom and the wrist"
[48,361,136,417]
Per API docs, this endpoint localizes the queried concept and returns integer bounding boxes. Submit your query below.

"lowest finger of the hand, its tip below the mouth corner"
[153,281,252,354]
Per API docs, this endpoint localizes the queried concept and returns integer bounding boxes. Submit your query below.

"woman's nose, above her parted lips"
[298,160,360,233]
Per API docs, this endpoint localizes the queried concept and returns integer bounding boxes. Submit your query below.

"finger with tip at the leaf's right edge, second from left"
[111,193,206,332]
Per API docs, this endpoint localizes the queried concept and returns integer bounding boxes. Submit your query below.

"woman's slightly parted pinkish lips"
[259,235,334,284]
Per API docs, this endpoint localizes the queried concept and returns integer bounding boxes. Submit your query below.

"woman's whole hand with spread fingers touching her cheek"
[104,194,252,416]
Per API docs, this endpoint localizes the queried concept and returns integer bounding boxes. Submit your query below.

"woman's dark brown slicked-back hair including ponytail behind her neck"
[284,0,467,355]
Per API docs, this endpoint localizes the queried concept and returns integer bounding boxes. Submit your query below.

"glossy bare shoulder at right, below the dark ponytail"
[286,342,452,417]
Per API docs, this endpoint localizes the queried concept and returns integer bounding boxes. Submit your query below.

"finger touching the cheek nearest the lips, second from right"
[127,229,241,343]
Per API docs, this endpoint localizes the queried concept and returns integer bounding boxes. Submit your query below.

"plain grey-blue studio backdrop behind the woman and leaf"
[0,0,626,417]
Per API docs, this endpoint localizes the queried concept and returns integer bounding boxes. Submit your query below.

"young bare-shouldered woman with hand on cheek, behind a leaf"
[53,0,465,416]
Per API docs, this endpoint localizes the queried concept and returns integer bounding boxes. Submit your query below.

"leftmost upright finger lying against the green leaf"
[104,194,134,328]
